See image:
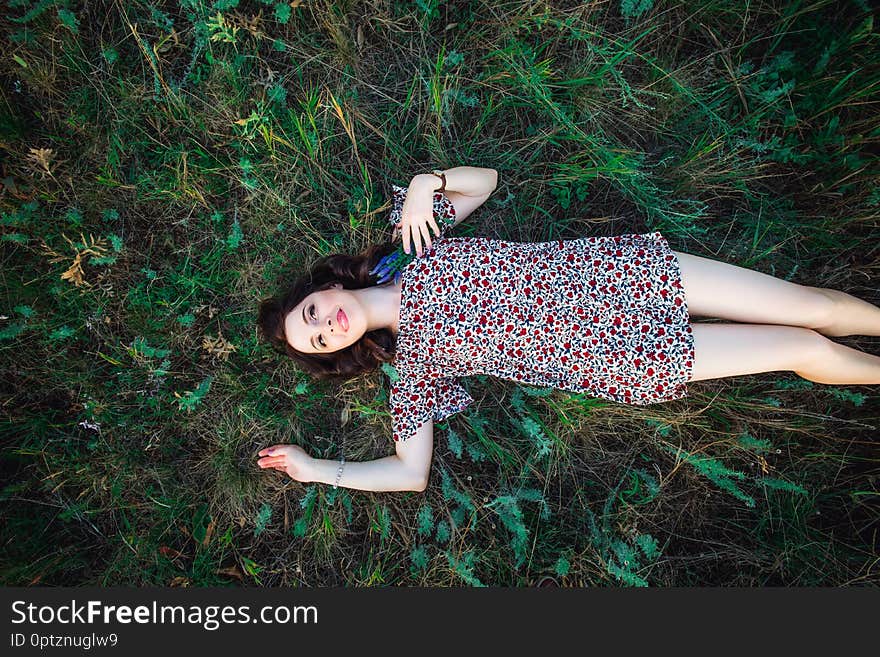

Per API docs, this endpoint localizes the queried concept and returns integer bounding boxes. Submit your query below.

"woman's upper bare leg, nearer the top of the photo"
[673,251,880,336]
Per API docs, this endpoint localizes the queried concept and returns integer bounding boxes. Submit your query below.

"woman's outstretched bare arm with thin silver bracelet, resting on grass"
[258,419,434,492]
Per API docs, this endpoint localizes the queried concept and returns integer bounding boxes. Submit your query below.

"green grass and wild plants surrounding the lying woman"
[0,0,880,586]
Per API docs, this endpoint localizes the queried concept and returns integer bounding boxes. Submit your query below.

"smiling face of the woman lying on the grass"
[284,283,367,354]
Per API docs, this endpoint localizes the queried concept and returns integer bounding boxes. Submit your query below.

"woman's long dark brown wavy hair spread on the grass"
[257,242,397,380]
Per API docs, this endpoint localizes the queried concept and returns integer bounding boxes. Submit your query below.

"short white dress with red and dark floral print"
[389,185,694,441]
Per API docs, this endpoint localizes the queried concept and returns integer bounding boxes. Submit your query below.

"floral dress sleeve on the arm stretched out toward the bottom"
[388,364,474,442]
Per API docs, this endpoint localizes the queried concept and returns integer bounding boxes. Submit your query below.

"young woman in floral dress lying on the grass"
[258,167,880,491]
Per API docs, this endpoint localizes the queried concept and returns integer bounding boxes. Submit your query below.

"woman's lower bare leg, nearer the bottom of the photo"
[690,323,880,385]
